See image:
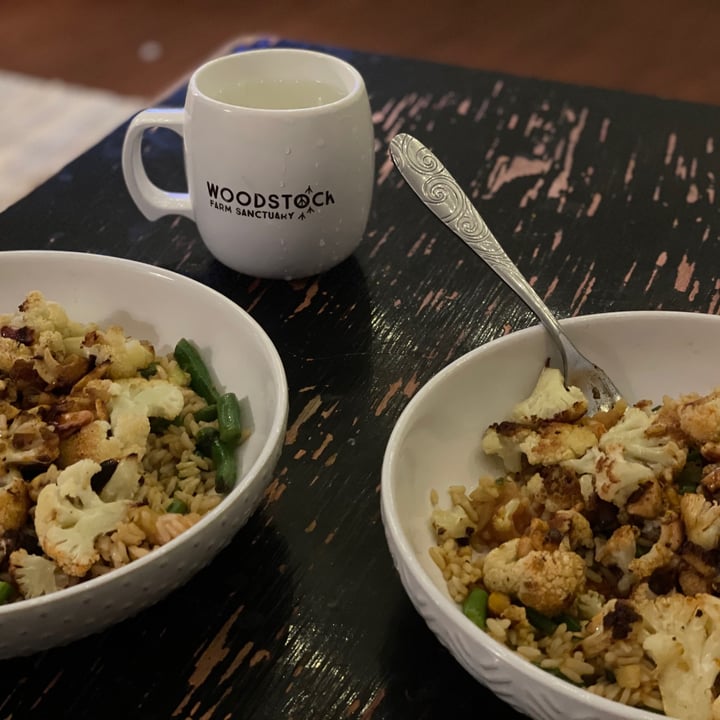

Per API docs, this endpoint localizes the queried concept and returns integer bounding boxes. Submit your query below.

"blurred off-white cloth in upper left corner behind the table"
[0,71,147,211]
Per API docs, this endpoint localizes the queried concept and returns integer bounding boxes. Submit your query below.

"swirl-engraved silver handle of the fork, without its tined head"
[390,133,577,377]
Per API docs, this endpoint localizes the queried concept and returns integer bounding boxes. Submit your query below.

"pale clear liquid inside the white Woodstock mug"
[209,79,346,110]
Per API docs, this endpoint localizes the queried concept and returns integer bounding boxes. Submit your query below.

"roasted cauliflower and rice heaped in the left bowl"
[0,291,233,603]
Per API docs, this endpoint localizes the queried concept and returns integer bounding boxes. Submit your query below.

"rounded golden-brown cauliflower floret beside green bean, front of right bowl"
[483,538,585,616]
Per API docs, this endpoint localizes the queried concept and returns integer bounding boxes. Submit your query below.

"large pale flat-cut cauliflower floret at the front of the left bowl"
[35,460,130,577]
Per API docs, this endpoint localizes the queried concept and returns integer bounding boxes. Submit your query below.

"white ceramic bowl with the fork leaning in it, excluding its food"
[381,311,720,720]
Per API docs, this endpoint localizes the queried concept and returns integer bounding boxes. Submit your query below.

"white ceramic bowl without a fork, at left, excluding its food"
[0,251,288,658]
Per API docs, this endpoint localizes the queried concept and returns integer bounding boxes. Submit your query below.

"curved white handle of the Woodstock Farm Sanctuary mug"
[122,108,194,220]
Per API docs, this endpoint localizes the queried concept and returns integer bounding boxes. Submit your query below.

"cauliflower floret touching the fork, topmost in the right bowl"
[510,367,588,425]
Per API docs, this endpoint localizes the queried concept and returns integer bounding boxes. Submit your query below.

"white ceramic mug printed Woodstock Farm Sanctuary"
[122,48,374,279]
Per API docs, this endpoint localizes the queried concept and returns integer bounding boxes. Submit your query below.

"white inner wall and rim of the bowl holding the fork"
[382,311,720,717]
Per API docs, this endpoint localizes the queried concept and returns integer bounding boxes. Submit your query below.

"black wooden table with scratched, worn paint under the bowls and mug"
[0,36,720,720]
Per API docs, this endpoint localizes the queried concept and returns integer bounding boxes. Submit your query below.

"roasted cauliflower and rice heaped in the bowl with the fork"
[429,368,720,720]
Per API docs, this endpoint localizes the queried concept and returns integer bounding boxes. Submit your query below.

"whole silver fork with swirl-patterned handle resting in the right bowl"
[390,133,622,415]
